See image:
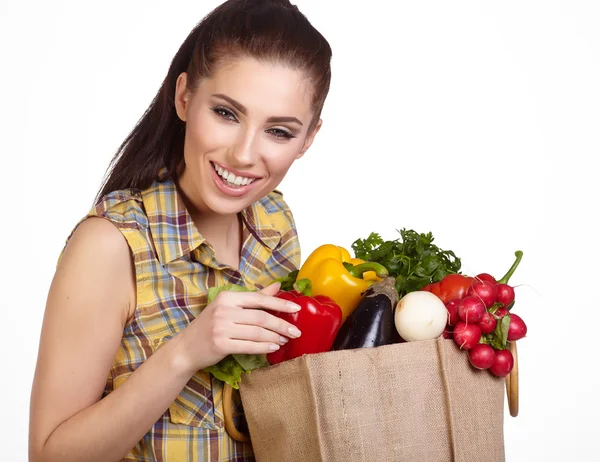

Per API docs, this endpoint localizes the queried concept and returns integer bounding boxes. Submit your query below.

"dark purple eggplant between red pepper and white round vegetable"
[331,277,402,351]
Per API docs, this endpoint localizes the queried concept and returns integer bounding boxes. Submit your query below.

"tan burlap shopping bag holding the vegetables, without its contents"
[240,339,504,462]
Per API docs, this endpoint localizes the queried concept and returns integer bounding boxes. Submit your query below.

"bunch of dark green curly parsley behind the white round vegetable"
[352,228,461,297]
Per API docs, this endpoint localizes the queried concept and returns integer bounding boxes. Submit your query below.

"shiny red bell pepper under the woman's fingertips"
[267,279,342,364]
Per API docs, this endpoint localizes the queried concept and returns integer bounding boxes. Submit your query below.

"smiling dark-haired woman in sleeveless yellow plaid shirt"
[30,0,331,462]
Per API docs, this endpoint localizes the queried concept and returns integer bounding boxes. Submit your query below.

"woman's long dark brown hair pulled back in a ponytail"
[96,0,331,200]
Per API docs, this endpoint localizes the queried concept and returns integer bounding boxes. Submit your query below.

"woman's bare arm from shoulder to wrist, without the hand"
[30,218,193,462]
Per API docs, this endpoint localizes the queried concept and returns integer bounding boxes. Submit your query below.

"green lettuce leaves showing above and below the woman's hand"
[203,284,269,389]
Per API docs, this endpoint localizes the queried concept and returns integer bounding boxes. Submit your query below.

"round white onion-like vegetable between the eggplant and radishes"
[394,290,448,342]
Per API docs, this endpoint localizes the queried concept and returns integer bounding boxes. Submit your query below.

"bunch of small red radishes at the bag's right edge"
[444,251,527,377]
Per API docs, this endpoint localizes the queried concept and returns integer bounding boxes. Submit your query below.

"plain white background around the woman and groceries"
[0,0,600,461]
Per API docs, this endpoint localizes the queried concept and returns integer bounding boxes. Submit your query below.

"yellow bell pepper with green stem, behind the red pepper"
[297,244,388,320]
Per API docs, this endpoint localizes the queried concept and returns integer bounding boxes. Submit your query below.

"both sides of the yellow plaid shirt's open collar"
[142,178,281,265]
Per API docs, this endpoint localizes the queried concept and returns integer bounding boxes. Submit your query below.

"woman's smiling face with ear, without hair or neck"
[175,58,321,215]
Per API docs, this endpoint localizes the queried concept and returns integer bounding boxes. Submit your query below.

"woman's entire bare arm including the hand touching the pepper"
[29,218,300,462]
